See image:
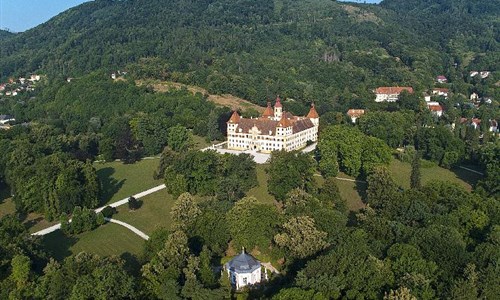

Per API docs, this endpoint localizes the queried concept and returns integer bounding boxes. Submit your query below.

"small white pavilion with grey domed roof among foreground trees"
[224,249,262,290]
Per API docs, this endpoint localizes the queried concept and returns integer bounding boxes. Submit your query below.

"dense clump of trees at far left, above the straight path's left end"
[7,148,100,219]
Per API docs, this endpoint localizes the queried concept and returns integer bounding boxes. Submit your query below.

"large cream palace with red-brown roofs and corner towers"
[227,97,319,153]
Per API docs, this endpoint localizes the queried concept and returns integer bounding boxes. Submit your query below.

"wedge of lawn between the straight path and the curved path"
[113,190,175,235]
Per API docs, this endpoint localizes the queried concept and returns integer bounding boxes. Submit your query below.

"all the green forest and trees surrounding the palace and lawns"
[0,0,500,300]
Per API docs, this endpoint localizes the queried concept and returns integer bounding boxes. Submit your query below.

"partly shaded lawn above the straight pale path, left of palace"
[94,159,162,205]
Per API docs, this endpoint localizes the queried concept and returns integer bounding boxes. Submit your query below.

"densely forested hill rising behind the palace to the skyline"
[0,0,500,111]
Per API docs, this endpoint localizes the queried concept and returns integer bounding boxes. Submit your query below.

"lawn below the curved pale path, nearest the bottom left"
[43,223,144,260]
